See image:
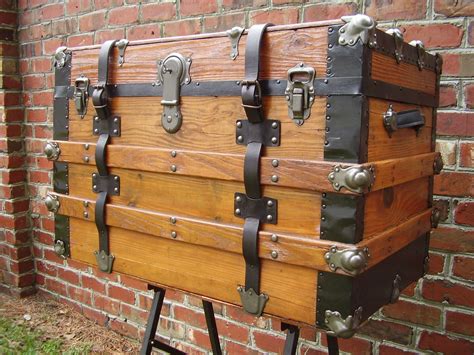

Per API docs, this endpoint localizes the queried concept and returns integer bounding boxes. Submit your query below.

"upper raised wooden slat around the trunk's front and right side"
[56,141,438,193]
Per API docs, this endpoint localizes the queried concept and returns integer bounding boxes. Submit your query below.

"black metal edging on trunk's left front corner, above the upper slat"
[53,49,72,141]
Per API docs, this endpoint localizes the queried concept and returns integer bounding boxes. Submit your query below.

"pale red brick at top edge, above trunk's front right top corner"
[365,0,426,20]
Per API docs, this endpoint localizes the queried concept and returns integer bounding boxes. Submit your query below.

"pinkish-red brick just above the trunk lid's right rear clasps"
[403,23,464,48]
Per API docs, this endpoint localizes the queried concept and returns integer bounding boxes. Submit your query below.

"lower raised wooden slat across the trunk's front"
[55,194,334,270]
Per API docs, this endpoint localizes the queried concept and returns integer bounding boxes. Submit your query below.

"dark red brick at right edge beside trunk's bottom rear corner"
[422,279,474,307]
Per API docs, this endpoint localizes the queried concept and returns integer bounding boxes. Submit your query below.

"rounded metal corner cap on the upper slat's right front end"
[328,165,375,194]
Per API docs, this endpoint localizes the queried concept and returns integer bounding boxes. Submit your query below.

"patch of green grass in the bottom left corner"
[0,316,92,355]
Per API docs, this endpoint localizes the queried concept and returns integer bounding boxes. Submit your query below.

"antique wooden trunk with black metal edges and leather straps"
[45,15,442,337]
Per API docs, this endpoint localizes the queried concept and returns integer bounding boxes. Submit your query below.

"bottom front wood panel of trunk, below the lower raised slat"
[70,218,317,325]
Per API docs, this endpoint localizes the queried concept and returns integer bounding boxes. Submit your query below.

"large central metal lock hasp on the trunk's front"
[158,53,192,133]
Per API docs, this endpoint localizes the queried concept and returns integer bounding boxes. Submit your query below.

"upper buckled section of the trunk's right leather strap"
[242,23,272,123]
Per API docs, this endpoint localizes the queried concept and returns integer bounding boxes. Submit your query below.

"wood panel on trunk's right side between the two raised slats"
[364,177,429,239]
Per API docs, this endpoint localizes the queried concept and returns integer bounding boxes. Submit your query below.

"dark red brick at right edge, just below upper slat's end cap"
[434,172,474,196]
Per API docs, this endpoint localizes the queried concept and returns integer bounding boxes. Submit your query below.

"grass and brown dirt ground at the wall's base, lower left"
[0,293,140,354]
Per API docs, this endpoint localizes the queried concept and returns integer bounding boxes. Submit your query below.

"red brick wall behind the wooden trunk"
[0,0,474,354]
